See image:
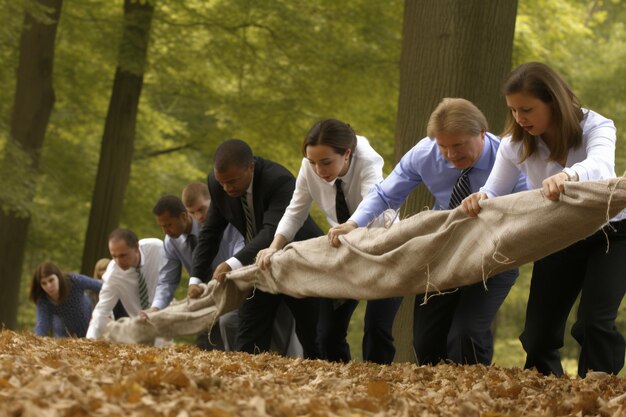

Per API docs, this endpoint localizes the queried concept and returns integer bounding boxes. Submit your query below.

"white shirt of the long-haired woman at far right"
[480,109,626,220]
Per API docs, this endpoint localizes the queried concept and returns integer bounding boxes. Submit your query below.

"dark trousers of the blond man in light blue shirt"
[413,269,519,365]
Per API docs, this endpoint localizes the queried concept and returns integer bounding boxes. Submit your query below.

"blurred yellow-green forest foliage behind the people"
[0,0,626,372]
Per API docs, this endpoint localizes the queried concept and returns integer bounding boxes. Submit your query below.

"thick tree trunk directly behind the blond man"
[394,0,517,361]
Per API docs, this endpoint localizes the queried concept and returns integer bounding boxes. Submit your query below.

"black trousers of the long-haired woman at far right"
[520,221,626,377]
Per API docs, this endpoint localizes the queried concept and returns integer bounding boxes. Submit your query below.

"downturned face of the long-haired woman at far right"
[506,92,552,137]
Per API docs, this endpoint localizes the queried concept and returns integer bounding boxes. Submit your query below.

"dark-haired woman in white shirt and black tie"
[257,119,401,364]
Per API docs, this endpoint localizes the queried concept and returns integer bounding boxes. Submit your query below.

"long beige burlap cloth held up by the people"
[109,178,626,342]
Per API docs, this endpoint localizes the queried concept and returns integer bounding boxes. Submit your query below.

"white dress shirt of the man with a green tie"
[87,238,165,339]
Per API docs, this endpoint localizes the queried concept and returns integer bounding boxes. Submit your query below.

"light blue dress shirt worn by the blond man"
[350,133,527,227]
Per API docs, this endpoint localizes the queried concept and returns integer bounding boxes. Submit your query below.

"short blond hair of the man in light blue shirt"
[426,98,489,139]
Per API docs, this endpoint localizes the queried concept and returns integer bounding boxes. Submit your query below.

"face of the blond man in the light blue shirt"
[435,132,485,169]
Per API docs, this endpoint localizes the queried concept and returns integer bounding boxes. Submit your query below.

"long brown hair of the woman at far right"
[502,62,583,162]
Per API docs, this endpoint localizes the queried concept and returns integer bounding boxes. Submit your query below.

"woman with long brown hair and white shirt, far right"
[463,62,626,377]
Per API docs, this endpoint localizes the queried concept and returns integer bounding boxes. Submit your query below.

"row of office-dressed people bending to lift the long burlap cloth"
[31,62,626,377]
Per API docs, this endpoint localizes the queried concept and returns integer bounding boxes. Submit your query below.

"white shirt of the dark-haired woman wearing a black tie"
[276,136,385,242]
